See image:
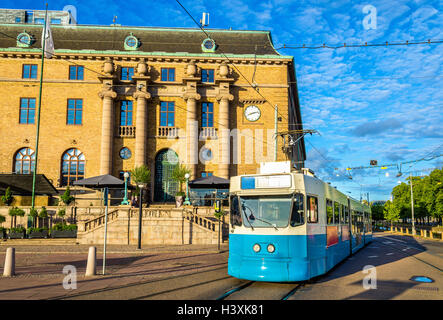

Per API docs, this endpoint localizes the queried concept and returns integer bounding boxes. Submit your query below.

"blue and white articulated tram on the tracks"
[228,169,372,282]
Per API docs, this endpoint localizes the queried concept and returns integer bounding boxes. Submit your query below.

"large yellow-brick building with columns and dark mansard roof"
[0,24,306,202]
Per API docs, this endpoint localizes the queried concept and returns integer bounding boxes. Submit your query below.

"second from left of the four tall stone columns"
[134,90,151,167]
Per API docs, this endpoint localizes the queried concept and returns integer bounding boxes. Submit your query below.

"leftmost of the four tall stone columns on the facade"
[99,89,117,175]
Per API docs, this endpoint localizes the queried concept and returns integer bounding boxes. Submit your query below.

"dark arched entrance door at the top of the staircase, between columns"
[154,149,178,202]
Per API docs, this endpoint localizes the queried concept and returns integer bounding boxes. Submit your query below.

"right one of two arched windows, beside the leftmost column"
[61,149,85,186]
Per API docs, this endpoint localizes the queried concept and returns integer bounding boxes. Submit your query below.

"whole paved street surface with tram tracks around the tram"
[0,233,443,300]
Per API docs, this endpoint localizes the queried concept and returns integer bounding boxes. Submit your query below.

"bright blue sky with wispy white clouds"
[4,0,443,201]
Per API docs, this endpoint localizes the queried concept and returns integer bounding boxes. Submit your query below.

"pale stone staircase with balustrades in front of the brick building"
[77,205,229,244]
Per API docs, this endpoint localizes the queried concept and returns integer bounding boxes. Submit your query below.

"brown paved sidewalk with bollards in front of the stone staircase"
[0,243,228,300]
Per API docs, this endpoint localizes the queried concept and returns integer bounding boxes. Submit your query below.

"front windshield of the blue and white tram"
[240,195,292,228]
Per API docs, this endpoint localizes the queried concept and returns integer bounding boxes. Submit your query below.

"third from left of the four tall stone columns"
[183,93,201,180]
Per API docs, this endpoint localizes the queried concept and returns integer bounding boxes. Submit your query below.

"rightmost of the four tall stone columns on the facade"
[217,93,234,179]
